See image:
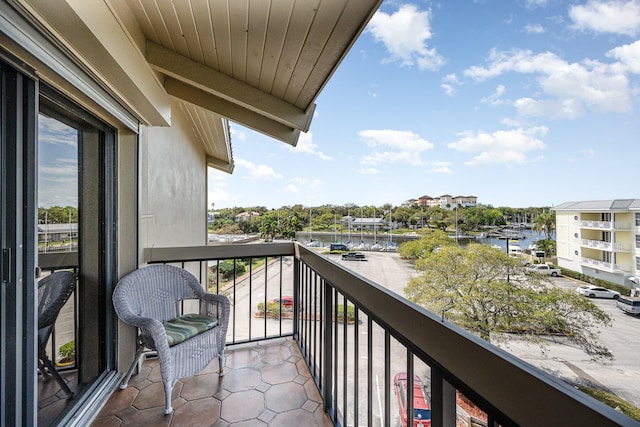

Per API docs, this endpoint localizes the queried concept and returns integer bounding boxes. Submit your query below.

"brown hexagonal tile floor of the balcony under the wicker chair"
[92,338,333,427]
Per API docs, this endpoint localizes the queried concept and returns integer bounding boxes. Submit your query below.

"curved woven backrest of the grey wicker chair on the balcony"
[113,264,204,322]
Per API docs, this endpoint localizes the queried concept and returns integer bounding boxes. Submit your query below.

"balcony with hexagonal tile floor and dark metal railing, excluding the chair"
[77,243,635,426]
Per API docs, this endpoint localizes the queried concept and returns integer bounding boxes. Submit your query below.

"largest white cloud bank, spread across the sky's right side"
[464,50,631,118]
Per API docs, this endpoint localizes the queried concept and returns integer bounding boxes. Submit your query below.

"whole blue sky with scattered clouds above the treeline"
[209,0,640,208]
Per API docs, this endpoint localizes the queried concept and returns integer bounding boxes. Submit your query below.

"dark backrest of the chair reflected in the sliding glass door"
[38,271,76,329]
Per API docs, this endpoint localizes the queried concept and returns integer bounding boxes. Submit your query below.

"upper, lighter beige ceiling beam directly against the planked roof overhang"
[146,41,315,132]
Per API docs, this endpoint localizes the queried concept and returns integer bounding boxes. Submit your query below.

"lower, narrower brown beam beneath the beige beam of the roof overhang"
[164,77,300,147]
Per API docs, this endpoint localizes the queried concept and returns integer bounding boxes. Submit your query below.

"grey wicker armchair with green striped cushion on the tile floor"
[113,265,230,414]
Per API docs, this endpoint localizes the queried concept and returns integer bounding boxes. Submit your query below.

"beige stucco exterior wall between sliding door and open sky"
[139,101,207,254]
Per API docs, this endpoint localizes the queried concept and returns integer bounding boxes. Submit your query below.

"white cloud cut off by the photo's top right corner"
[569,0,640,36]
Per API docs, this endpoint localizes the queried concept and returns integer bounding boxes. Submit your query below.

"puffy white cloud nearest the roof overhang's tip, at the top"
[367,4,445,70]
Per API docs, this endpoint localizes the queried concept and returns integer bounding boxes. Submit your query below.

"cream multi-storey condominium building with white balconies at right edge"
[552,199,640,287]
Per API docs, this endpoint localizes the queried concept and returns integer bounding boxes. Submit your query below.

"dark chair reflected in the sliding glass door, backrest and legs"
[38,271,76,399]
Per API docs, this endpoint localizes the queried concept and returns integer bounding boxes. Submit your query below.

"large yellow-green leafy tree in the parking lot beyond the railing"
[405,244,612,359]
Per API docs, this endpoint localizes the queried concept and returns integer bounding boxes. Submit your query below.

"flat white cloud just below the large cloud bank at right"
[448,126,547,166]
